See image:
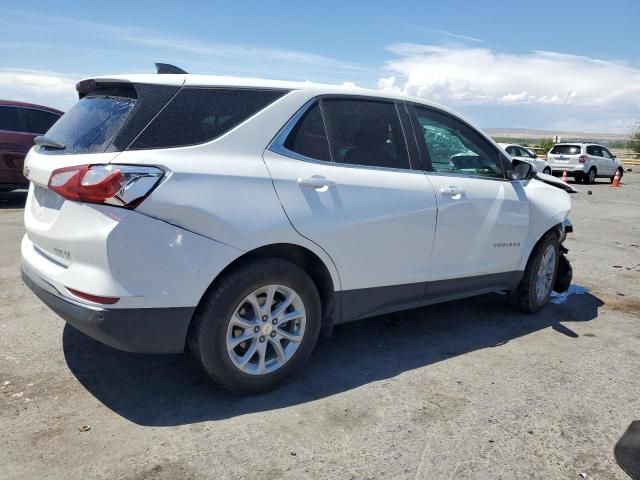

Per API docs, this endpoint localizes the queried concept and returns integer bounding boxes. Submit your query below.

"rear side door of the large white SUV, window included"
[264,96,436,300]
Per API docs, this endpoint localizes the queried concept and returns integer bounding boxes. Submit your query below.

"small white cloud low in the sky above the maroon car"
[0,69,78,110]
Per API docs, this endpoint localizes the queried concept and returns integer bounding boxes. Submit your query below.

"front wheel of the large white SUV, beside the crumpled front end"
[511,232,560,313]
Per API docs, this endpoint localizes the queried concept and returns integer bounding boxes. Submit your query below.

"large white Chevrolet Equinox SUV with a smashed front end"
[22,69,571,392]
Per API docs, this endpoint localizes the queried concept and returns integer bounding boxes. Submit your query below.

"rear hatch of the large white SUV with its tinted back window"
[25,80,180,265]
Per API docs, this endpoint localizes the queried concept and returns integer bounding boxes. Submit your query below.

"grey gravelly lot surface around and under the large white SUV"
[0,173,640,479]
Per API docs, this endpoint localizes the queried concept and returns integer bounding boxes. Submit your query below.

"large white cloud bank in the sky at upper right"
[378,43,640,131]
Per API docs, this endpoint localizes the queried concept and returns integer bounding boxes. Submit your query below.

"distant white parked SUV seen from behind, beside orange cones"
[547,142,624,183]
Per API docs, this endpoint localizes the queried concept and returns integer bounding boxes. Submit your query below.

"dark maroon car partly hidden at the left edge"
[0,100,63,192]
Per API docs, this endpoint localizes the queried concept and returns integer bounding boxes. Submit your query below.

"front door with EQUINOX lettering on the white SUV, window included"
[412,105,529,288]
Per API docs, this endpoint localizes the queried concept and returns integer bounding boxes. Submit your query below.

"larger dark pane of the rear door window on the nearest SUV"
[322,98,411,169]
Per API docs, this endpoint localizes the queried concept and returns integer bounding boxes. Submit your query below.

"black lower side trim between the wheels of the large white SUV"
[336,271,524,323]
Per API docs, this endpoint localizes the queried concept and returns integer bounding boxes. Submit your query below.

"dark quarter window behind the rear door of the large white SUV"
[130,87,287,149]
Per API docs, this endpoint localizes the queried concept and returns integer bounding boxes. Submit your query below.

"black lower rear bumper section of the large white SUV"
[22,265,195,353]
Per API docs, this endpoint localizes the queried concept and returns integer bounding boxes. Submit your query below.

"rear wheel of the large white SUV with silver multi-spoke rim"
[189,258,321,394]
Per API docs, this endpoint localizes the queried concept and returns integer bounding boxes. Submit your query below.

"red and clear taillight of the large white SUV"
[49,165,164,208]
